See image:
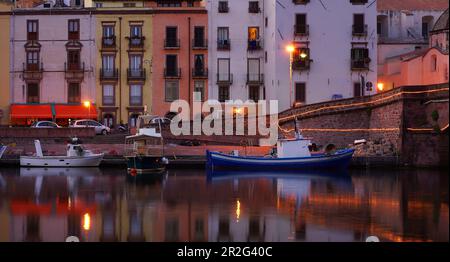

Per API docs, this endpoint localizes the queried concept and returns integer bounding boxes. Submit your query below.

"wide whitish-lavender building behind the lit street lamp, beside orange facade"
[207,0,377,110]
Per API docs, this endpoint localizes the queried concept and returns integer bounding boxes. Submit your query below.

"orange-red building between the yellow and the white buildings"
[145,0,208,116]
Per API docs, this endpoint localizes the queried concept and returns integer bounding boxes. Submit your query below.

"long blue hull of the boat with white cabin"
[207,149,354,170]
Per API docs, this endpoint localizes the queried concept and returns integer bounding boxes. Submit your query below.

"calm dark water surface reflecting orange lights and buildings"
[0,168,449,242]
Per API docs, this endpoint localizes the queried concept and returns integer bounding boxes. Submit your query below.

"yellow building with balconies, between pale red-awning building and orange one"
[93,1,152,127]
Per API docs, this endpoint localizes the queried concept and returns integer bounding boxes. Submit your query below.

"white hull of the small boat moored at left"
[20,154,103,167]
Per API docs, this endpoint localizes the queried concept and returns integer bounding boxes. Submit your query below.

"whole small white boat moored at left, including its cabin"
[20,138,104,167]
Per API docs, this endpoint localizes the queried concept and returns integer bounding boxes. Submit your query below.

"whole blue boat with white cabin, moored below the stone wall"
[206,130,354,171]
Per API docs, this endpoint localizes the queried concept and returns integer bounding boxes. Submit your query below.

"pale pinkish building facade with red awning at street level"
[10,1,96,125]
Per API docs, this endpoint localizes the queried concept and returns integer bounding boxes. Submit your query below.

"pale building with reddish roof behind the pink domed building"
[377,0,448,89]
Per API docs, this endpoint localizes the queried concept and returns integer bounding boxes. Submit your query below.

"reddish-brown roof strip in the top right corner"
[377,0,448,11]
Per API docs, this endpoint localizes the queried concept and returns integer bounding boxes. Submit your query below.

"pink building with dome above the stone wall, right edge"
[378,9,449,89]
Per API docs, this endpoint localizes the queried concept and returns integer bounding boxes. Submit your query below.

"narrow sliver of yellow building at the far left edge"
[0,0,13,125]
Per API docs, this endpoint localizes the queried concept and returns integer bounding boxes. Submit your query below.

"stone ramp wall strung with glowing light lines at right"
[280,84,449,166]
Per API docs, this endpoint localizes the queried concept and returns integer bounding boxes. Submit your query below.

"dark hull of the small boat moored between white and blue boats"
[125,156,166,174]
